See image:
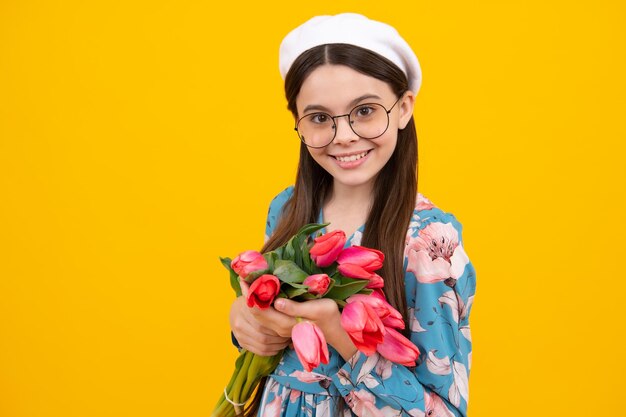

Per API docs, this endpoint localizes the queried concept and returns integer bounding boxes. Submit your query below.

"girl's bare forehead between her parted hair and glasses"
[296,64,393,113]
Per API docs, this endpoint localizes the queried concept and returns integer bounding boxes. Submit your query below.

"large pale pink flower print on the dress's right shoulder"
[405,222,469,287]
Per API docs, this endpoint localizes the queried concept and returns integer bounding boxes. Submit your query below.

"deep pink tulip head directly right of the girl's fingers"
[341,301,385,356]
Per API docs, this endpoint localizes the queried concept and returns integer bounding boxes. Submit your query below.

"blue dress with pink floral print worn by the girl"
[258,186,476,417]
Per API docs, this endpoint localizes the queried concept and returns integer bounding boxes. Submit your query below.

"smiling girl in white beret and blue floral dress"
[230,14,475,417]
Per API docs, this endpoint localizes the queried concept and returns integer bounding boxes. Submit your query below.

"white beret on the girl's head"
[278,13,422,94]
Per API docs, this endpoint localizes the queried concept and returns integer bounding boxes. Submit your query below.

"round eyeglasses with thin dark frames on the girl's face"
[294,95,402,148]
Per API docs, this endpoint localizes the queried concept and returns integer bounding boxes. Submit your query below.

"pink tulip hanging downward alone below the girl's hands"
[291,321,329,372]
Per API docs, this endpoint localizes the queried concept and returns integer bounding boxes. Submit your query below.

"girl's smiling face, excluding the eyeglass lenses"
[296,64,414,192]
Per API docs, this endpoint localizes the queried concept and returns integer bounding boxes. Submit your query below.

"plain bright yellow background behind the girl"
[0,0,626,417]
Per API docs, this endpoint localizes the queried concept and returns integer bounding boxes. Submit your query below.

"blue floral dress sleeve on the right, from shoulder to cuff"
[332,208,476,417]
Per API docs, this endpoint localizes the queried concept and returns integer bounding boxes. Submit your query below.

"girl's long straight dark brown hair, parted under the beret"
[244,44,417,416]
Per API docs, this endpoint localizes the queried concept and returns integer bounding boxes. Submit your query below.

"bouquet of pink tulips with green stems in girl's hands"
[212,223,419,417]
